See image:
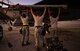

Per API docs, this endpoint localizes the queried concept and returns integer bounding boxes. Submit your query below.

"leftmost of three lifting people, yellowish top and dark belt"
[20,14,29,46]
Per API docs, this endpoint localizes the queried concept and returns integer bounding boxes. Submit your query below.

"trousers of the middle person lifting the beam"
[35,27,45,47]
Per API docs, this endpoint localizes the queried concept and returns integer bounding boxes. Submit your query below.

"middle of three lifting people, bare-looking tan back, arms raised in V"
[30,7,46,51]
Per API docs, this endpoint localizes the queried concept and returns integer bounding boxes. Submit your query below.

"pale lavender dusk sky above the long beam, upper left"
[0,0,41,7]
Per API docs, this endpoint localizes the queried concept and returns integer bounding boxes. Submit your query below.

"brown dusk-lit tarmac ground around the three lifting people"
[0,21,80,51]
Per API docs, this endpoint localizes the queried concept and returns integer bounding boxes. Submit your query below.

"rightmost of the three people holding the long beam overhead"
[48,8,60,37]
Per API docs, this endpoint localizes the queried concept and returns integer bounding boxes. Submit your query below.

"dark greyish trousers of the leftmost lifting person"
[22,26,29,44]
